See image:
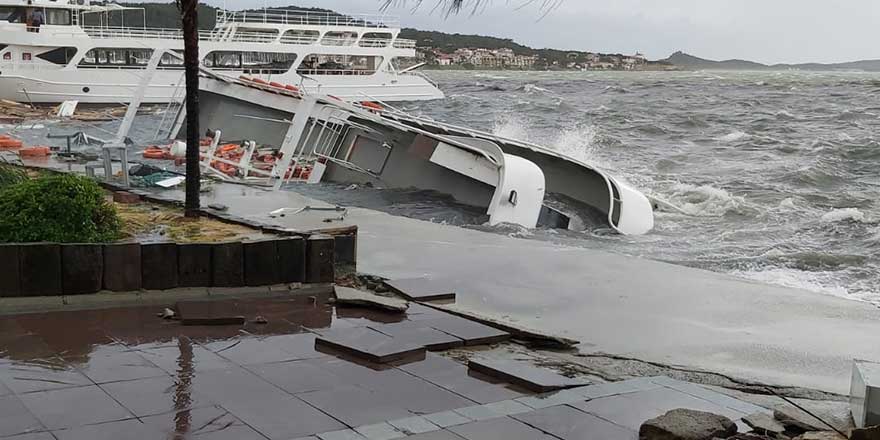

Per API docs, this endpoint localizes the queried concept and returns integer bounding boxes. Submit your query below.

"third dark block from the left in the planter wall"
[61,244,104,295]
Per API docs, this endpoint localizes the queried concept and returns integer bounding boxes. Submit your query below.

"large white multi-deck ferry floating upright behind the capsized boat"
[0,0,443,103]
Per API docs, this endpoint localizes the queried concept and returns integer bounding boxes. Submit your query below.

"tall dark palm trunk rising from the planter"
[177,0,201,217]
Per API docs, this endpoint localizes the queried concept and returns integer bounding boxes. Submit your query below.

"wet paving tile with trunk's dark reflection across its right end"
[100,376,211,417]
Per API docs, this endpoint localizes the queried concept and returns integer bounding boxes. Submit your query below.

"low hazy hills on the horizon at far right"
[660,51,880,72]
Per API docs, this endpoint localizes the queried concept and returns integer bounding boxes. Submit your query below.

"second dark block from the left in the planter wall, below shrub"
[18,243,62,296]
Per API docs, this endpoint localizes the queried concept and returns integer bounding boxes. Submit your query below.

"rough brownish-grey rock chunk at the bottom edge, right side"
[639,409,737,440]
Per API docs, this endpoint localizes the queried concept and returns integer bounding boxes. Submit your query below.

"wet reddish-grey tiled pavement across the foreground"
[0,292,761,440]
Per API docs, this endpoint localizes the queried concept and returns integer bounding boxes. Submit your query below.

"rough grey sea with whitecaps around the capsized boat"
[8,71,880,305]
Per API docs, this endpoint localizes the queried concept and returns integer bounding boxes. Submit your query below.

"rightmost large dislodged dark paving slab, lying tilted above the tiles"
[468,357,591,393]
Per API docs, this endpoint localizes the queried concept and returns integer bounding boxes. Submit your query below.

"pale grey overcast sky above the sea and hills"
[209,0,880,63]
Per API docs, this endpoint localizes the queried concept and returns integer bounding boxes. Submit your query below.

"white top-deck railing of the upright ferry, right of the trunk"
[217,9,400,28]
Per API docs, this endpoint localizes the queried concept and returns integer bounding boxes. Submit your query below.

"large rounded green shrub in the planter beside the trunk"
[0,174,121,243]
